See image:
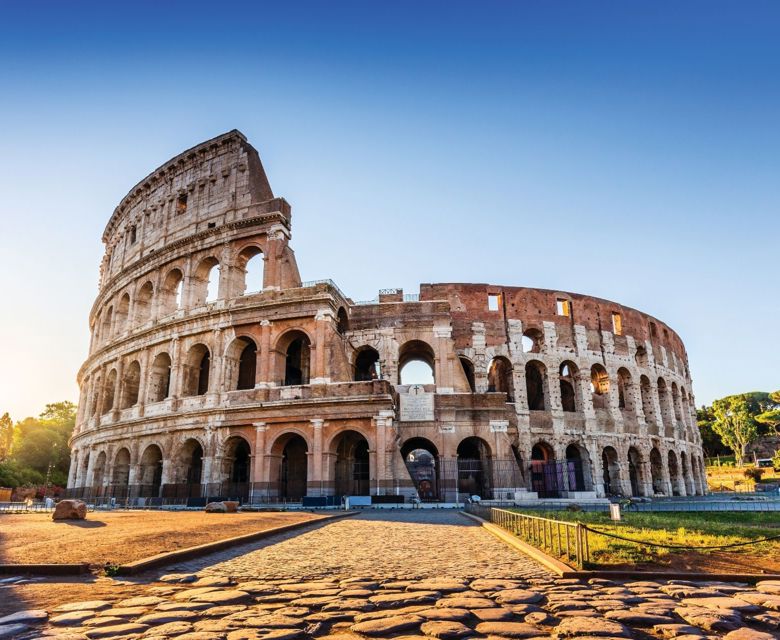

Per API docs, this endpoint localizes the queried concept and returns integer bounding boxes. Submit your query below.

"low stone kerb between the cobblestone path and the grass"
[460,511,780,583]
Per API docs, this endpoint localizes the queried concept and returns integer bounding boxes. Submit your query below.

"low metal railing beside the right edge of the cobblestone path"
[466,504,590,569]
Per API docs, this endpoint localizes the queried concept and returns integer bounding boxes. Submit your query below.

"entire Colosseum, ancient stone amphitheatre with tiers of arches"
[68,131,706,505]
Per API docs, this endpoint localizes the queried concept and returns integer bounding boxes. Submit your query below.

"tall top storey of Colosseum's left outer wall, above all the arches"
[101,130,278,285]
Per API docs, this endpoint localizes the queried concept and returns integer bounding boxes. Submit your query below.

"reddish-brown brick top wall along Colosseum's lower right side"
[420,283,688,365]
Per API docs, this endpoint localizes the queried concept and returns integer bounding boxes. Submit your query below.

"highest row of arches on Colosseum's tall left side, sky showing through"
[92,245,264,347]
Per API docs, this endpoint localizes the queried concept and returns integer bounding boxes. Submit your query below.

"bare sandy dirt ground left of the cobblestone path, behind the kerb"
[0,511,322,566]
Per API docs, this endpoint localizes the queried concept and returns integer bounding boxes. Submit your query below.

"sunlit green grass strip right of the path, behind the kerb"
[517,510,780,566]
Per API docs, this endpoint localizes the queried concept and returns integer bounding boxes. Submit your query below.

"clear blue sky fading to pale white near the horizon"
[0,0,780,419]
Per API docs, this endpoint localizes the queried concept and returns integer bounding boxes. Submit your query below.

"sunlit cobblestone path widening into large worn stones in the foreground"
[0,512,780,640]
